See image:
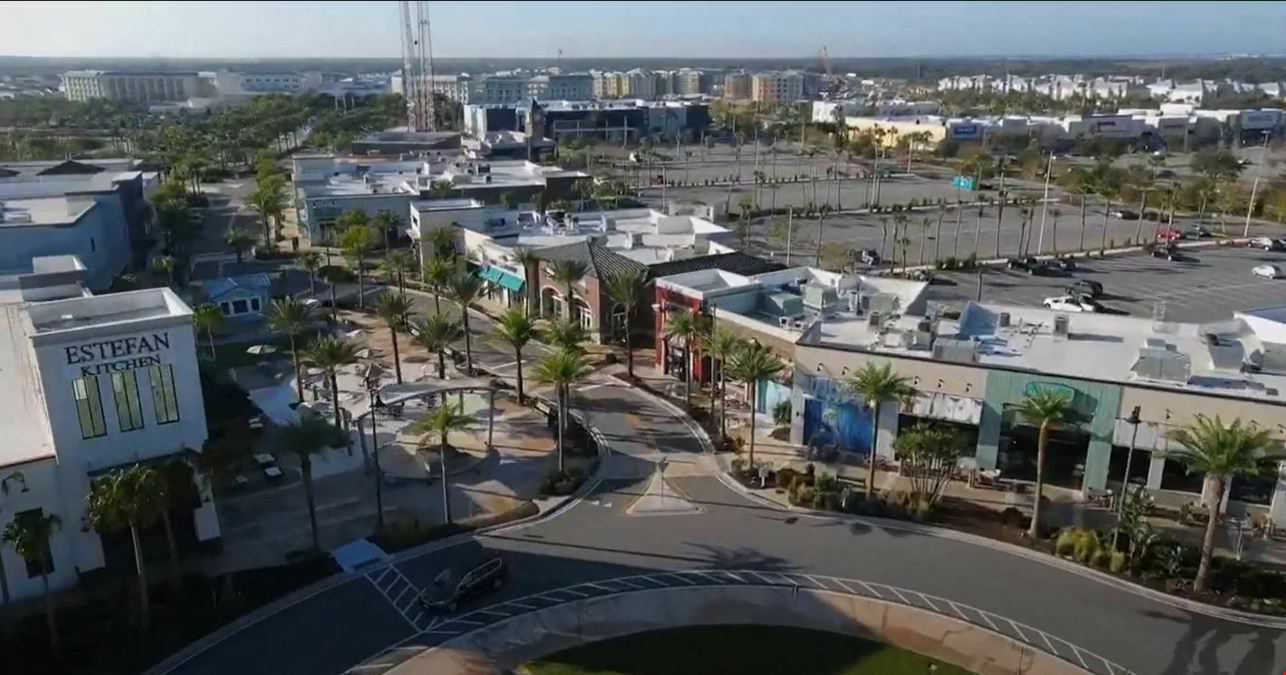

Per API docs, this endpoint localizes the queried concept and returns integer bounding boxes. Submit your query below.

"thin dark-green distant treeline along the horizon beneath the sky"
[0,57,1286,82]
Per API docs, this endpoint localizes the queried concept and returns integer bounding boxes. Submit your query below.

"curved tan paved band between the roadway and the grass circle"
[390,586,1087,675]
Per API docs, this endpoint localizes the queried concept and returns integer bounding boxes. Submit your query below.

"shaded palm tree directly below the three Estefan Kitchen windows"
[87,464,165,634]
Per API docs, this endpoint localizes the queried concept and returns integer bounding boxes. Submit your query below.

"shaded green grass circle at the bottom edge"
[520,626,968,675]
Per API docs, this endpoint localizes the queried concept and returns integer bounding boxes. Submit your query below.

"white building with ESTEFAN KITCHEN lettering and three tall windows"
[0,256,220,599]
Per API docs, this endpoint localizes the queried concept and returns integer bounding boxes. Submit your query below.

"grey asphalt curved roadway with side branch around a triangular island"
[165,379,1286,675]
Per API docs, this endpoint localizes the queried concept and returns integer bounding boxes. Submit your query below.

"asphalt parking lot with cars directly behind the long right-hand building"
[930,247,1286,323]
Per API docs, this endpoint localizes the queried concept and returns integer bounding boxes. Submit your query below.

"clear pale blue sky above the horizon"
[0,0,1286,58]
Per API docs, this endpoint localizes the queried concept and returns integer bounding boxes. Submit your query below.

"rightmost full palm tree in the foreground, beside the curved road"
[1169,414,1273,593]
